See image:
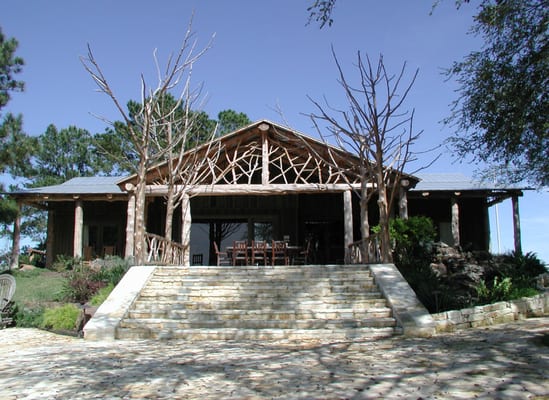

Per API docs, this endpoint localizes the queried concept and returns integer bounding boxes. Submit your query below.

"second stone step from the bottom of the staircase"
[128,307,391,321]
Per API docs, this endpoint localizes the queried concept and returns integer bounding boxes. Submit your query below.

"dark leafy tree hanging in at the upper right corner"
[445,0,549,186]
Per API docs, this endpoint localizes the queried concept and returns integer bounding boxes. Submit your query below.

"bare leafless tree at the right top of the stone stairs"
[310,49,421,262]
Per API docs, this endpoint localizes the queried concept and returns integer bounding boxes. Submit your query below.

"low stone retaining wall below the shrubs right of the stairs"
[432,291,549,333]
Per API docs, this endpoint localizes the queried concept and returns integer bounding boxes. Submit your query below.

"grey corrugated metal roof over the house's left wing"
[15,176,125,194]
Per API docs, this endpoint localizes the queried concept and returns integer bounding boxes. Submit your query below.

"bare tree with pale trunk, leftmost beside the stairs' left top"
[82,21,214,264]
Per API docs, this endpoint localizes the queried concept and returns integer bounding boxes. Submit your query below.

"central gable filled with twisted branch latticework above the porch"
[119,120,417,187]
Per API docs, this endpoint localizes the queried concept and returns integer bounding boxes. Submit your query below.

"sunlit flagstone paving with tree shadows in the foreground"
[0,318,549,400]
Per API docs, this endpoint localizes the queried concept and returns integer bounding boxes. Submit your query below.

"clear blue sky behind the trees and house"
[0,0,549,261]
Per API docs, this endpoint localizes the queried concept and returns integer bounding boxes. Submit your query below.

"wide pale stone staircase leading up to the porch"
[116,265,400,341]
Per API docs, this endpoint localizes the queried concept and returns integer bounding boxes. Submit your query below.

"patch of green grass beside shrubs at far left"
[12,268,66,306]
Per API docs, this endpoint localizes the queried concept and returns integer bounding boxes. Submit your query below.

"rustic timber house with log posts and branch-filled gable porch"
[7,120,522,265]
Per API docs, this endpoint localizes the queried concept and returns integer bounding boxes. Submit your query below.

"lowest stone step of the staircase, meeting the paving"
[116,327,395,342]
